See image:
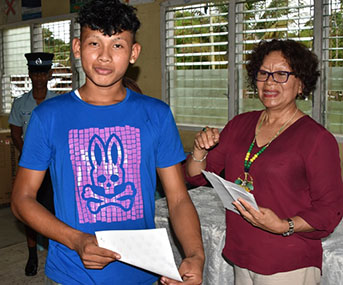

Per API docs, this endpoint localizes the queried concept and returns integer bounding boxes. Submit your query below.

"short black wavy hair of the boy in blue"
[77,0,140,40]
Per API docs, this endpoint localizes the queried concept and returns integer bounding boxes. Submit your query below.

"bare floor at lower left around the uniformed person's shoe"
[0,207,47,285]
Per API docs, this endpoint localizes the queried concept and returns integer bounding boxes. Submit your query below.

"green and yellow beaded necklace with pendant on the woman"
[235,108,298,192]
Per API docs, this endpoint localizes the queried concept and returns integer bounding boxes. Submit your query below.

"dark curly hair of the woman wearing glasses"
[246,39,320,96]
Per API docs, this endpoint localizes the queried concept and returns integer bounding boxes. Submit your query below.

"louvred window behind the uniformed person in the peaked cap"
[0,17,73,114]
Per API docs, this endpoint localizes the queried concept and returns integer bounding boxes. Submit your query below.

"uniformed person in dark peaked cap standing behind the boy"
[8,52,58,276]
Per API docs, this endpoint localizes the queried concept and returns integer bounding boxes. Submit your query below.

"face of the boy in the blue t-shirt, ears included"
[73,28,140,87]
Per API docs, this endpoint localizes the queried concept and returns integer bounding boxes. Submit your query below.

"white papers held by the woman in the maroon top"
[202,170,258,214]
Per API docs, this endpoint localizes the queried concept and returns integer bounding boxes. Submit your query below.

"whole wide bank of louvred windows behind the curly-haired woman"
[161,0,343,134]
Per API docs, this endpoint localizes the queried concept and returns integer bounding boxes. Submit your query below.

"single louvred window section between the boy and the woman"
[165,3,228,126]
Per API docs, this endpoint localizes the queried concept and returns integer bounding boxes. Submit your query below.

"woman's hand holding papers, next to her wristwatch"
[232,198,289,234]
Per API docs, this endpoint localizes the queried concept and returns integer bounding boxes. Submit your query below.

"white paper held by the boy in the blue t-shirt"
[95,228,182,282]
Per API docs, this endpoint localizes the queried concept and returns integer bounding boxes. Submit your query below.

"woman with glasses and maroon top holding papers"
[186,40,343,285]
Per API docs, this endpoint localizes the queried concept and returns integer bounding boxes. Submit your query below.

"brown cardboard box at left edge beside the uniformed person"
[0,130,18,205]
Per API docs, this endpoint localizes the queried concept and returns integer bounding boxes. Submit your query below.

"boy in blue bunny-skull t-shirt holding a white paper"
[12,0,204,285]
